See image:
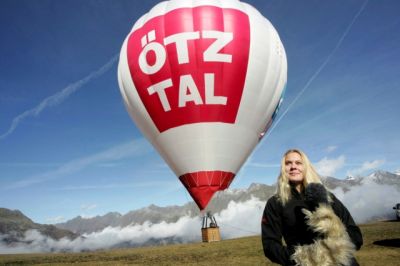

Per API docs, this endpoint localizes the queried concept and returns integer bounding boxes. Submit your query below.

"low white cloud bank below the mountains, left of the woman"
[0,198,265,254]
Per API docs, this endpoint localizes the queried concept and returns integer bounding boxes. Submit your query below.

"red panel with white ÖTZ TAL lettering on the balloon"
[127,6,250,132]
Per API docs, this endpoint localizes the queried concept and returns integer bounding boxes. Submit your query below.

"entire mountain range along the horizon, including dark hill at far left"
[0,171,400,244]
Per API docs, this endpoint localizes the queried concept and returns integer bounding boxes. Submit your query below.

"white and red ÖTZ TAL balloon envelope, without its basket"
[118,0,287,210]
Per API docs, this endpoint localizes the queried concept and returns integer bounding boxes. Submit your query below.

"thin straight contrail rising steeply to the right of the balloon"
[265,0,369,137]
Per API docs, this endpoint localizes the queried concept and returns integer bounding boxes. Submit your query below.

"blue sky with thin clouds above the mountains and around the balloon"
[0,0,400,223]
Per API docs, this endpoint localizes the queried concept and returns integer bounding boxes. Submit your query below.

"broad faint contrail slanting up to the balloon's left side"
[0,55,118,140]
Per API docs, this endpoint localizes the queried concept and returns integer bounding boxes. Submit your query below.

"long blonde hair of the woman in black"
[276,149,321,205]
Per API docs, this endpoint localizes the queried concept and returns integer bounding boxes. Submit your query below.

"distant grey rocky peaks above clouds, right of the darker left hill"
[55,171,400,234]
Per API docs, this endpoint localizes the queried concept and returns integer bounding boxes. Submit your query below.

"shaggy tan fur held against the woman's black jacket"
[291,203,355,266]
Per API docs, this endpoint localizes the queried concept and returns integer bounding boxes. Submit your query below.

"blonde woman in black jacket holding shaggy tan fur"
[261,149,363,266]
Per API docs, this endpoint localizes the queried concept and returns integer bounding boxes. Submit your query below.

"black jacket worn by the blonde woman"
[261,188,363,265]
